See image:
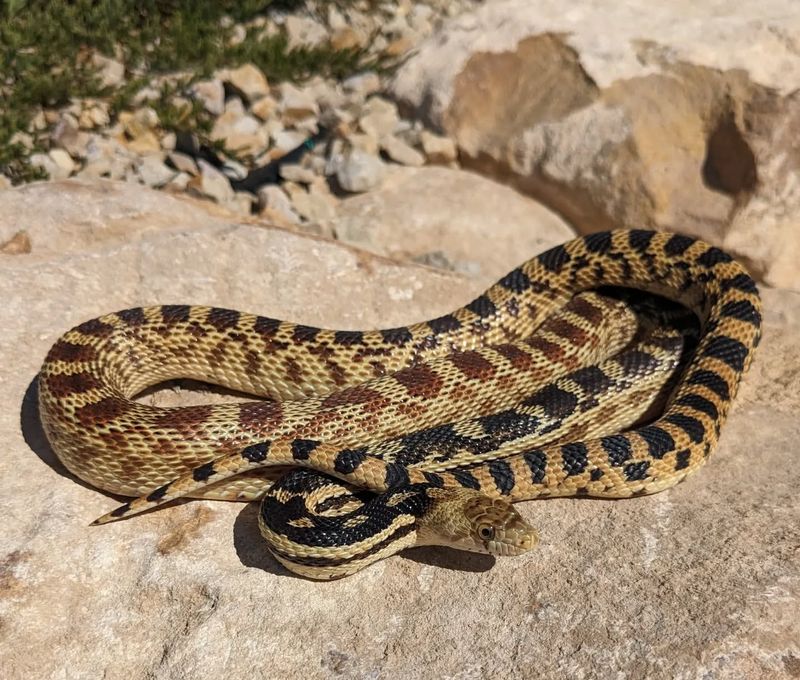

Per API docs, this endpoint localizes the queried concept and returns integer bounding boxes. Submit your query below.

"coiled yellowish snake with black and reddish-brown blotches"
[38,229,761,579]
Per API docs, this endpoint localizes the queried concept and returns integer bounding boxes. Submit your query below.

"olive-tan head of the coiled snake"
[417,489,539,556]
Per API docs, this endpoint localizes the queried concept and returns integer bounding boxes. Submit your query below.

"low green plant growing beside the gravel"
[0,0,380,183]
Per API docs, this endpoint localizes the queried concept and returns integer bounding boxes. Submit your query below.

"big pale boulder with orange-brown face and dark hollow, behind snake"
[393,0,800,289]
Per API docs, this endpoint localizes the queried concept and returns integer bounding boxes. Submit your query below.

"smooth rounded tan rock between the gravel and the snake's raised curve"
[325,167,575,286]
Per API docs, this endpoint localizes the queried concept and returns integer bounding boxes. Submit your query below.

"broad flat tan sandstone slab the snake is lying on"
[0,181,800,680]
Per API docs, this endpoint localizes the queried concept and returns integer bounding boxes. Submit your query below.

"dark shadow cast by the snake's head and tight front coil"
[233,503,495,581]
